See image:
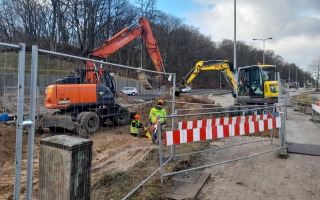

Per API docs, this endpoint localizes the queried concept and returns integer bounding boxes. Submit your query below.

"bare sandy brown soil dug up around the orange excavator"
[0,93,212,199]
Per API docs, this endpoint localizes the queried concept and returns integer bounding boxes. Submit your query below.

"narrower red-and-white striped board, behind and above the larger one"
[178,113,279,129]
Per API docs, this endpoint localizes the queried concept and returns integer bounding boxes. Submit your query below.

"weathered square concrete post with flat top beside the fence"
[38,135,92,200]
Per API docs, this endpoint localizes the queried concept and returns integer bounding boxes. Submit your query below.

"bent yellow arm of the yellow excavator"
[175,60,237,96]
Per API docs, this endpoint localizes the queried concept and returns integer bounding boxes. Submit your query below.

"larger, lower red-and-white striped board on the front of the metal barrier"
[164,116,281,146]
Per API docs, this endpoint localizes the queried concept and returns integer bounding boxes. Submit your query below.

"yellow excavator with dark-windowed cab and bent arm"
[175,60,278,105]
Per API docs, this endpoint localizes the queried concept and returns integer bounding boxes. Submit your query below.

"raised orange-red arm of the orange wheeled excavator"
[86,17,164,88]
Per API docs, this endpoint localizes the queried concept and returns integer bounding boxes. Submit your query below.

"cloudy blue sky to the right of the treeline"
[157,0,320,70]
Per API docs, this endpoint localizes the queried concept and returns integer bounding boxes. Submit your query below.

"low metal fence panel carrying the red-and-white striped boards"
[158,101,286,182]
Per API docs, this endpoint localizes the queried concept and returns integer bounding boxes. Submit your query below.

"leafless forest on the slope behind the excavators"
[0,0,320,88]
